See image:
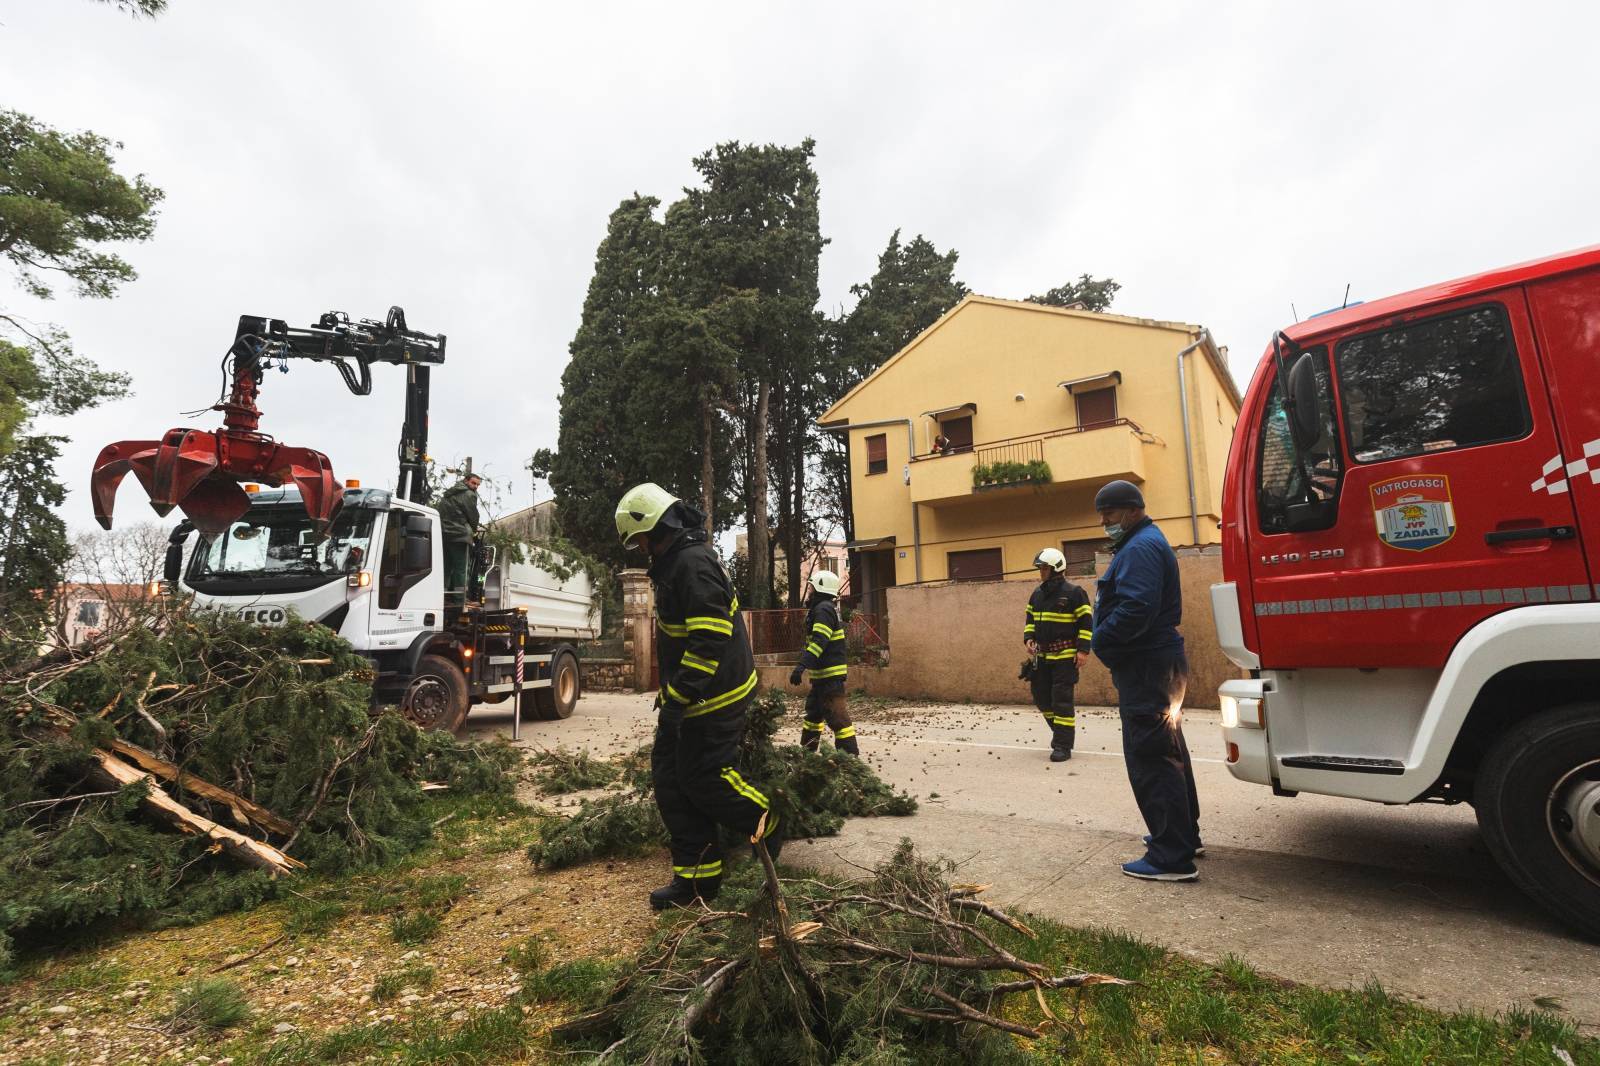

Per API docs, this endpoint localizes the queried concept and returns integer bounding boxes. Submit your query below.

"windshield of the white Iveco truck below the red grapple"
[187,506,374,594]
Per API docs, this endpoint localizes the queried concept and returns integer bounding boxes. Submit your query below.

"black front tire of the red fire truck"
[1472,704,1600,940]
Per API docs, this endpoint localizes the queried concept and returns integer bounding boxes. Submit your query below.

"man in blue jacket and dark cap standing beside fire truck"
[1093,482,1203,880]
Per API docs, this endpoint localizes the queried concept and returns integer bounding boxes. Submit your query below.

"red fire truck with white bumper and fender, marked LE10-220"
[1211,246,1600,936]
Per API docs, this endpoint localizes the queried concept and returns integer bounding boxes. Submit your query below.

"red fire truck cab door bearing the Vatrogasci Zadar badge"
[1246,288,1590,669]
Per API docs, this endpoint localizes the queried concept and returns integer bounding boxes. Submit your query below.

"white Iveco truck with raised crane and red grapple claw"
[93,307,598,730]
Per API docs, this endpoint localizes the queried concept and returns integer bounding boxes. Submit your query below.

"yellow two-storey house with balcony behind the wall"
[819,296,1238,597]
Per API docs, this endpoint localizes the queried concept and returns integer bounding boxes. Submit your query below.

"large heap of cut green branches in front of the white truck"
[0,607,517,966]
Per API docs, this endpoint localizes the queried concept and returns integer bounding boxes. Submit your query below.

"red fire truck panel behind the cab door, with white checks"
[1528,262,1600,573]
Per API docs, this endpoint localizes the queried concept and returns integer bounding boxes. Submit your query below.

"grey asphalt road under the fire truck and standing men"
[469,693,1600,1031]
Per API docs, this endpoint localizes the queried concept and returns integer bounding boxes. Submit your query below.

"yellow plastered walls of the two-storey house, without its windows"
[822,296,1238,584]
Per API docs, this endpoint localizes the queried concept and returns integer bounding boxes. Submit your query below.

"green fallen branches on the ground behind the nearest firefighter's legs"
[528,690,917,869]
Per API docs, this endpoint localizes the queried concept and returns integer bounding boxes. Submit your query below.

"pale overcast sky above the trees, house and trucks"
[0,0,1600,528]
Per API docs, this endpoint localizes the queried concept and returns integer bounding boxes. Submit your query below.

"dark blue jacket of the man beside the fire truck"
[1093,517,1184,666]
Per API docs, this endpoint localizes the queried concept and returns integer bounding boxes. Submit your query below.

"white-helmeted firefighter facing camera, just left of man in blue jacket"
[1022,547,1093,762]
